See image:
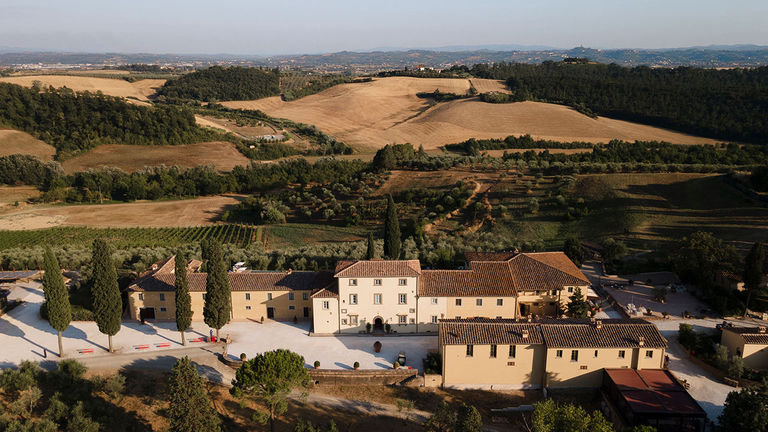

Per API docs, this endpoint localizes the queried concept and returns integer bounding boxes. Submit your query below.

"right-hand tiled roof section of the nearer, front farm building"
[540,319,667,348]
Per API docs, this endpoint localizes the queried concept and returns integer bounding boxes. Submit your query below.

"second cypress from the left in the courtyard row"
[91,239,123,352]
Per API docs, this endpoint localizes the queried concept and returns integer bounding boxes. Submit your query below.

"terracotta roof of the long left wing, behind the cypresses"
[128,271,334,292]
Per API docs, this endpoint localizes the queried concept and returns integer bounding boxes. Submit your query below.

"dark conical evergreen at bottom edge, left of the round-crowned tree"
[168,357,221,432]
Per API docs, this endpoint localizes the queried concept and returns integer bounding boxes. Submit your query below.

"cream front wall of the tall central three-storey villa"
[338,277,418,333]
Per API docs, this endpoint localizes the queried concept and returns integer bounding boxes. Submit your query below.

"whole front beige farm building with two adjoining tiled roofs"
[439,319,667,389]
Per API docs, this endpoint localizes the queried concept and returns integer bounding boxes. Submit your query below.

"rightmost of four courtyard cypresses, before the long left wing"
[203,240,232,340]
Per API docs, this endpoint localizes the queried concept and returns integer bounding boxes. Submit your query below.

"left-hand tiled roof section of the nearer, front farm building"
[440,319,543,345]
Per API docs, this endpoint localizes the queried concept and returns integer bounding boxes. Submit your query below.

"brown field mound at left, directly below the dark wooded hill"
[62,141,250,173]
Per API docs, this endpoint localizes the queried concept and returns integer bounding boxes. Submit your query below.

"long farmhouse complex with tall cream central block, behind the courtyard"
[128,252,589,334]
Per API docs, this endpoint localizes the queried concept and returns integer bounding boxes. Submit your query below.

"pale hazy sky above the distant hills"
[0,0,768,54]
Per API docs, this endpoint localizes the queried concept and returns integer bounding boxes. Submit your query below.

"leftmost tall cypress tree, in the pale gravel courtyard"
[43,246,72,357]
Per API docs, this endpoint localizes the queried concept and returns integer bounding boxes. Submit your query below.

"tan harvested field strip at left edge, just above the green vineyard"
[0,195,245,230]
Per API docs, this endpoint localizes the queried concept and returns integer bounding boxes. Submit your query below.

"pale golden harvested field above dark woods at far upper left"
[0,75,165,101]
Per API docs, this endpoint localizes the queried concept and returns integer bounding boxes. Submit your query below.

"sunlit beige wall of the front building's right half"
[546,347,665,388]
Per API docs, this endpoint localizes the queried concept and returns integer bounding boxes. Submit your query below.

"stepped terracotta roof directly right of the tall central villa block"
[419,261,520,297]
